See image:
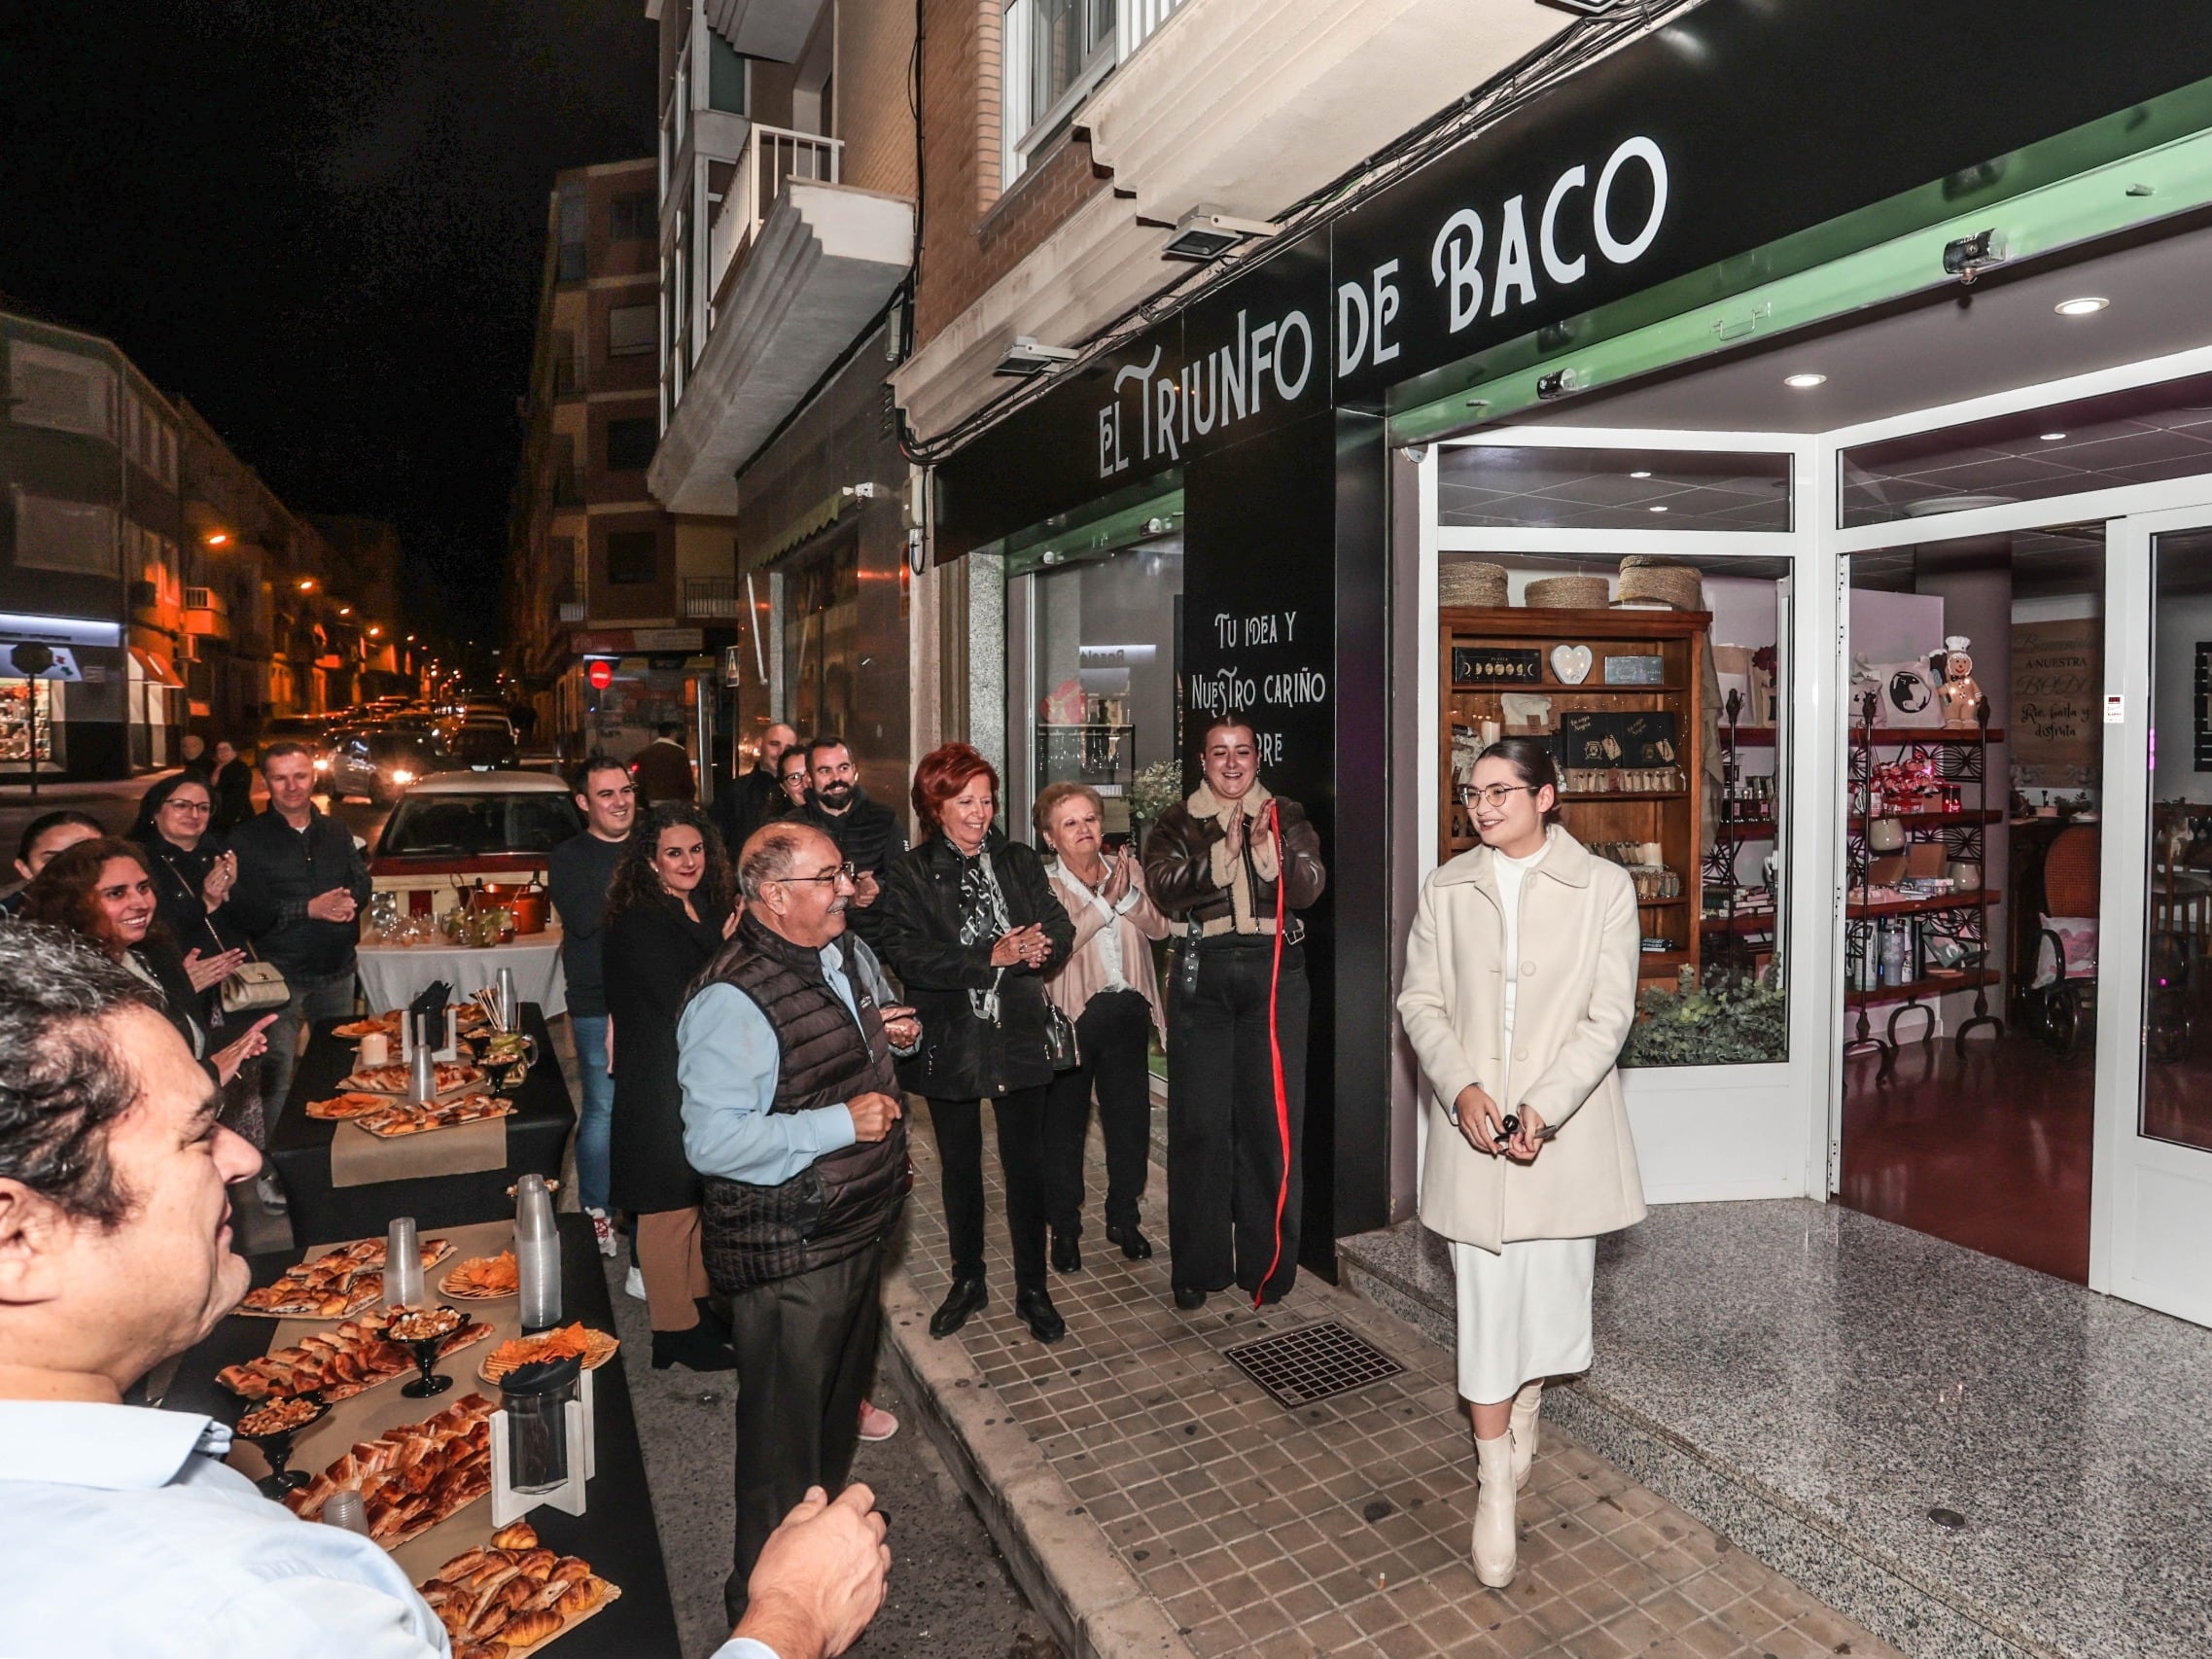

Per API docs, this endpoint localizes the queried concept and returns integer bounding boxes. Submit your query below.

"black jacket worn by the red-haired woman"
[874,834,1075,1100]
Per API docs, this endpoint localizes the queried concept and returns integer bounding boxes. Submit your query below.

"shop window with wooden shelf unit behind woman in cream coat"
[1438,546,1789,1066]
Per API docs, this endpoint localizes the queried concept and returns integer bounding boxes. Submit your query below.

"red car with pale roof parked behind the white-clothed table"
[369,772,584,909]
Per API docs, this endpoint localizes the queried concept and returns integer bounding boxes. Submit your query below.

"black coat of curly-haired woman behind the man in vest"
[600,894,727,1215]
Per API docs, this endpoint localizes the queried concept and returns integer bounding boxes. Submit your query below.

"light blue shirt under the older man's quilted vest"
[681,944,860,1185]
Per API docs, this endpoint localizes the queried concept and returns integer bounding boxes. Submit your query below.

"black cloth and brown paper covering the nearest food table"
[161,1215,682,1659]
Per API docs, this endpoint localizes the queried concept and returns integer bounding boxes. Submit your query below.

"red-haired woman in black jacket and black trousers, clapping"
[876,743,1075,1343]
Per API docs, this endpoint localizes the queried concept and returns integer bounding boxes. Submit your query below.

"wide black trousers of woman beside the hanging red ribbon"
[1168,940,1312,1301]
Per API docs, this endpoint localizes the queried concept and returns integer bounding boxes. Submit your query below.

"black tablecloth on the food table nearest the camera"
[161,1212,682,1659]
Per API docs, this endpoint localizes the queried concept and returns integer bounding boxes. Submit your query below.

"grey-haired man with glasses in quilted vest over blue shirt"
[677,823,920,1619]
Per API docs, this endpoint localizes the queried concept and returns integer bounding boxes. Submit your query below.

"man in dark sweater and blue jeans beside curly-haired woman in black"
[546,755,637,1256]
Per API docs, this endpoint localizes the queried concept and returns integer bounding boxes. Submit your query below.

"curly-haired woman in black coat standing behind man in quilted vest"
[600,800,737,1371]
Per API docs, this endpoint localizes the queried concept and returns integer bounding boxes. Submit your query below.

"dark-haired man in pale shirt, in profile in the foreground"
[0,927,890,1659]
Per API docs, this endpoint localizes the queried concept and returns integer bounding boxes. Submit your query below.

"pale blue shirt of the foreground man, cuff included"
[0,1400,777,1659]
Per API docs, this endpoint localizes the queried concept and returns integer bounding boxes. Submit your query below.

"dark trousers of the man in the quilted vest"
[721,1250,883,1624]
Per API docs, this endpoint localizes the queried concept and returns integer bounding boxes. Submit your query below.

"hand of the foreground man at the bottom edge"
[730,1482,892,1659]
